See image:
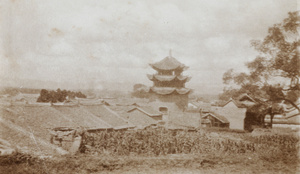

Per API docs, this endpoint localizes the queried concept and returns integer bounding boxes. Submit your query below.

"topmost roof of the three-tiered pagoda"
[150,57,186,70]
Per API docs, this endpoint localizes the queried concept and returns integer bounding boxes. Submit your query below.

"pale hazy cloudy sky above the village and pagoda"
[0,0,299,93]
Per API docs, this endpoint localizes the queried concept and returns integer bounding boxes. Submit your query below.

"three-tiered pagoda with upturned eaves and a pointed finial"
[147,51,191,108]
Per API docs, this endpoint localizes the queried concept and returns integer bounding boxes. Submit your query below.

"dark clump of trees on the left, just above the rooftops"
[37,88,86,103]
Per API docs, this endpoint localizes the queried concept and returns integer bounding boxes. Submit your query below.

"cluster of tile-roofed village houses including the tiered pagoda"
[0,53,300,152]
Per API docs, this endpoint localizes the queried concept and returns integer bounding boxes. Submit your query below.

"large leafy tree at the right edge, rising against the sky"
[220,12,300,128]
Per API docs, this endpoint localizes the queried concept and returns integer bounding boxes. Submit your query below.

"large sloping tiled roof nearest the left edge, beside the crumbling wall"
[0,106,78,153]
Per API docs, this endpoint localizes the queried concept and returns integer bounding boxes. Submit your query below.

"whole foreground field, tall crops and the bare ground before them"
[0,127,300,173]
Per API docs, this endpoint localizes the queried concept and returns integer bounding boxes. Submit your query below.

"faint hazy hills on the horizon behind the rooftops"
[0,77,218,102]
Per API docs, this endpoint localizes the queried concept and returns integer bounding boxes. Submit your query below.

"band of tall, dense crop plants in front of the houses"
[82,129,299,155]
